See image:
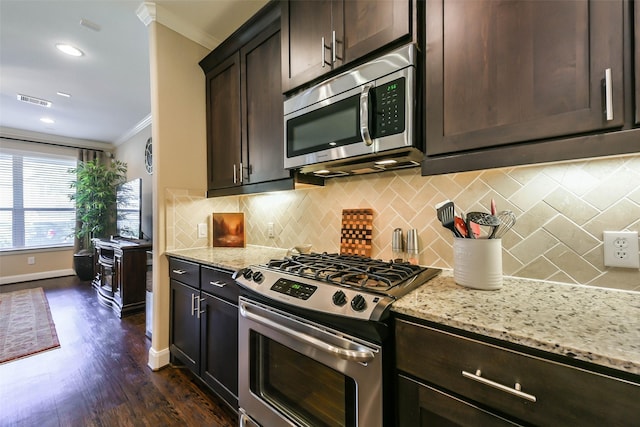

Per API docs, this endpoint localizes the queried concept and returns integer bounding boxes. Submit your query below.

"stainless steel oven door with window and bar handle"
[238,297,383,427]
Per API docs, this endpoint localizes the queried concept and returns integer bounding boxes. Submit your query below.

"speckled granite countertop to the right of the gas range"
[392,270,640,374]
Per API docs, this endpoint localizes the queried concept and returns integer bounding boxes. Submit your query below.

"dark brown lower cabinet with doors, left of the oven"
[169,258,239,410]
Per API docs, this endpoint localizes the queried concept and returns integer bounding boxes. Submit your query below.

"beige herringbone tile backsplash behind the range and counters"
[166,156,640,291]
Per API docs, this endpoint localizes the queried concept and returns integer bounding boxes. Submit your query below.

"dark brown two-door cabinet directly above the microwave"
[282,0,414,92]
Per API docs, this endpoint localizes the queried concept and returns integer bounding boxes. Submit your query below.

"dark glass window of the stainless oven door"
[250,331,356,427]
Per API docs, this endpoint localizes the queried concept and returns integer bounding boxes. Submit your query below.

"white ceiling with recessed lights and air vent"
[0,0,267,145]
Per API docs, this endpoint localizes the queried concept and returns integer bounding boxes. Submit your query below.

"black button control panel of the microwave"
[373,77,406,138]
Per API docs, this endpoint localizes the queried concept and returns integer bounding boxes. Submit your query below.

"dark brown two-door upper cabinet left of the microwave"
[200,1,321,197]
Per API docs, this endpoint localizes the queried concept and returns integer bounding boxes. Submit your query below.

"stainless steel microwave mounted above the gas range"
[284,44,423,177]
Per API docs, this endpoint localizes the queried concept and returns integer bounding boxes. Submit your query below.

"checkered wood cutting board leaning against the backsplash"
[340,209,373,257]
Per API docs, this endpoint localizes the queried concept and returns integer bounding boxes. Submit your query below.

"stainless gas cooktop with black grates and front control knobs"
[234,252,440,321]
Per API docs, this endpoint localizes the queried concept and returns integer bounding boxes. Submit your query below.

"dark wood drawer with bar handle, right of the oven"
[396,320,640,426]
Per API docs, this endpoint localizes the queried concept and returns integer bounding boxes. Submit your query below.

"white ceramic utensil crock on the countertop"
[453,238,502,290]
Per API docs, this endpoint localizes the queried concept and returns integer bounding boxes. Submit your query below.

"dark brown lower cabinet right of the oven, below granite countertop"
[395,318,640,427]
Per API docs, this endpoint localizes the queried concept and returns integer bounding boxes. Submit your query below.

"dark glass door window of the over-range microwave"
[287,95,362,157]
